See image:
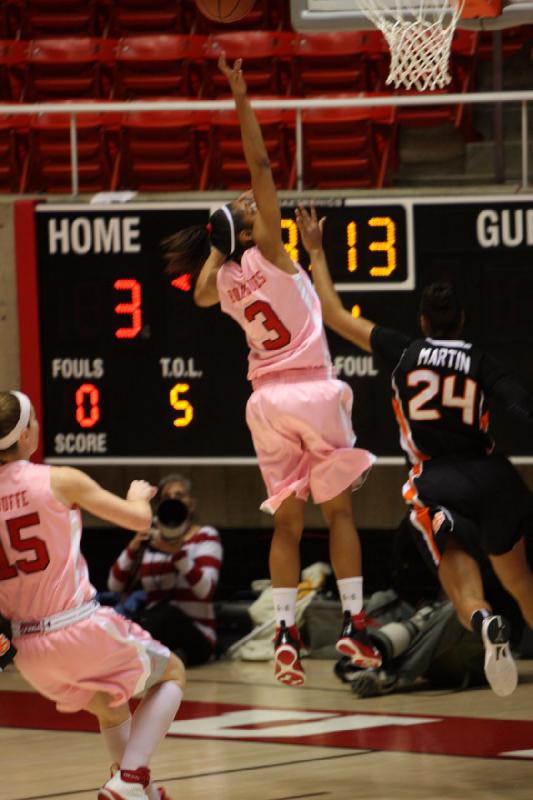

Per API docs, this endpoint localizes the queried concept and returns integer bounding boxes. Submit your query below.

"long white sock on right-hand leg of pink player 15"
[120,681,183,769]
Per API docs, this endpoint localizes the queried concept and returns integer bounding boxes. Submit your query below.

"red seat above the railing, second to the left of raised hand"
[24,38,116,102]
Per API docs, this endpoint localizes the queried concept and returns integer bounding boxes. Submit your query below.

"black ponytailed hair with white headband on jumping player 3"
[161,205,243,280]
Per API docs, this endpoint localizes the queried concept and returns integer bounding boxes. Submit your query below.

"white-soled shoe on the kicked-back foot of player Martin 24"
[481,614,518,697]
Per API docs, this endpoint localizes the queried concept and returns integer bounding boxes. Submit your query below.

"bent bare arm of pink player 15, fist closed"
[51,467,156,531]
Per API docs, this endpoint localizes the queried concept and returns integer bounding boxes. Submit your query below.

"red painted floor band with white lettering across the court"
[0,692,533,760]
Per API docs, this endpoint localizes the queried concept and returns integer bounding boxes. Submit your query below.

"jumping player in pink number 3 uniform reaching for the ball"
[164,55,381,685]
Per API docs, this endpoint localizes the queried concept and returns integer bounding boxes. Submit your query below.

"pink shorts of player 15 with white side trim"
[15,606,170,711]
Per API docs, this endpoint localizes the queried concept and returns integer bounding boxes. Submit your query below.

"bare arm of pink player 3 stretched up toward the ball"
[218,54,296,273]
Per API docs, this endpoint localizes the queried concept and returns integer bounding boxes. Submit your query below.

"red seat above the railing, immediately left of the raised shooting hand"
[114,34,205,100]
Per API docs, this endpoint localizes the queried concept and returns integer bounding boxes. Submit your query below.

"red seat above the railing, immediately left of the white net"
[292,31,388,97]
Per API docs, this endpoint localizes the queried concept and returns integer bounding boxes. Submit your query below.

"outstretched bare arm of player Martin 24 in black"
[295,204,375,352]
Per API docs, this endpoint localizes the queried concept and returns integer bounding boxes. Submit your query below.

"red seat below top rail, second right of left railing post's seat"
[113,111,206,192]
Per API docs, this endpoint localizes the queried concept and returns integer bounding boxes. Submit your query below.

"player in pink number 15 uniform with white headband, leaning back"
[0,392,185,800]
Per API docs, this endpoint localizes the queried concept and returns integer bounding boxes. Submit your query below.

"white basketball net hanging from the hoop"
[359,0,464,92]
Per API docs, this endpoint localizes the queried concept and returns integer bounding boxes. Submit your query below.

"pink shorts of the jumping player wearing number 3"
[246,375,375,514]
